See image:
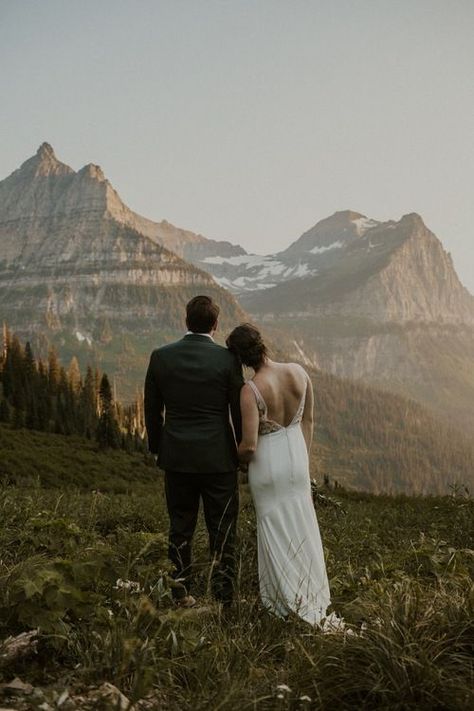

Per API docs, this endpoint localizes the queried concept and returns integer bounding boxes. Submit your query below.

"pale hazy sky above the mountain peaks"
[0,0,474,290]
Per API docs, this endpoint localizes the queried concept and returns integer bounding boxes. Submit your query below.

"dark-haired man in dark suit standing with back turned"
[145,296,243,607]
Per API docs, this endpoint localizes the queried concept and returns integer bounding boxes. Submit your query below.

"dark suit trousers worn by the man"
[165,471,239,602]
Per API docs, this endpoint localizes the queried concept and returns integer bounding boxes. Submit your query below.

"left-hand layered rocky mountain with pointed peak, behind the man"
[0,143,245,395]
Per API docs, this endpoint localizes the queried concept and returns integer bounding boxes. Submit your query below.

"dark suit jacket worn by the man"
[145,333,243,474]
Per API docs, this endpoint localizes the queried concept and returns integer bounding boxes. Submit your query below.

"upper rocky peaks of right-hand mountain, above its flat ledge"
[242,213,474,325]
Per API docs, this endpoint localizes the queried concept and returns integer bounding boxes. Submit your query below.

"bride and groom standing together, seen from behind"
[145,296,337,628]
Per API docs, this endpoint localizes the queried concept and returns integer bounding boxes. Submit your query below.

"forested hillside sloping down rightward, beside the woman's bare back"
[312,372,474,495]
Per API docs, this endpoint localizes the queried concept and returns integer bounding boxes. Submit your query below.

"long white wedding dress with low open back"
[247,380,335,626]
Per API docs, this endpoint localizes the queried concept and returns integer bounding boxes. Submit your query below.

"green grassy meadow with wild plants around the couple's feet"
[0,430,474,711]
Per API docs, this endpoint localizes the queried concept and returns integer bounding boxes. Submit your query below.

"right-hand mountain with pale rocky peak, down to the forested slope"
[240,212,474,432]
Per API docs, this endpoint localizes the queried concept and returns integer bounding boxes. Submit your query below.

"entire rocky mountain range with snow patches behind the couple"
[0,143,474,433]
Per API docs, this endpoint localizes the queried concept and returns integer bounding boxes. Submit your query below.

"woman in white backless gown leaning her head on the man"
[227,324,344,631]
